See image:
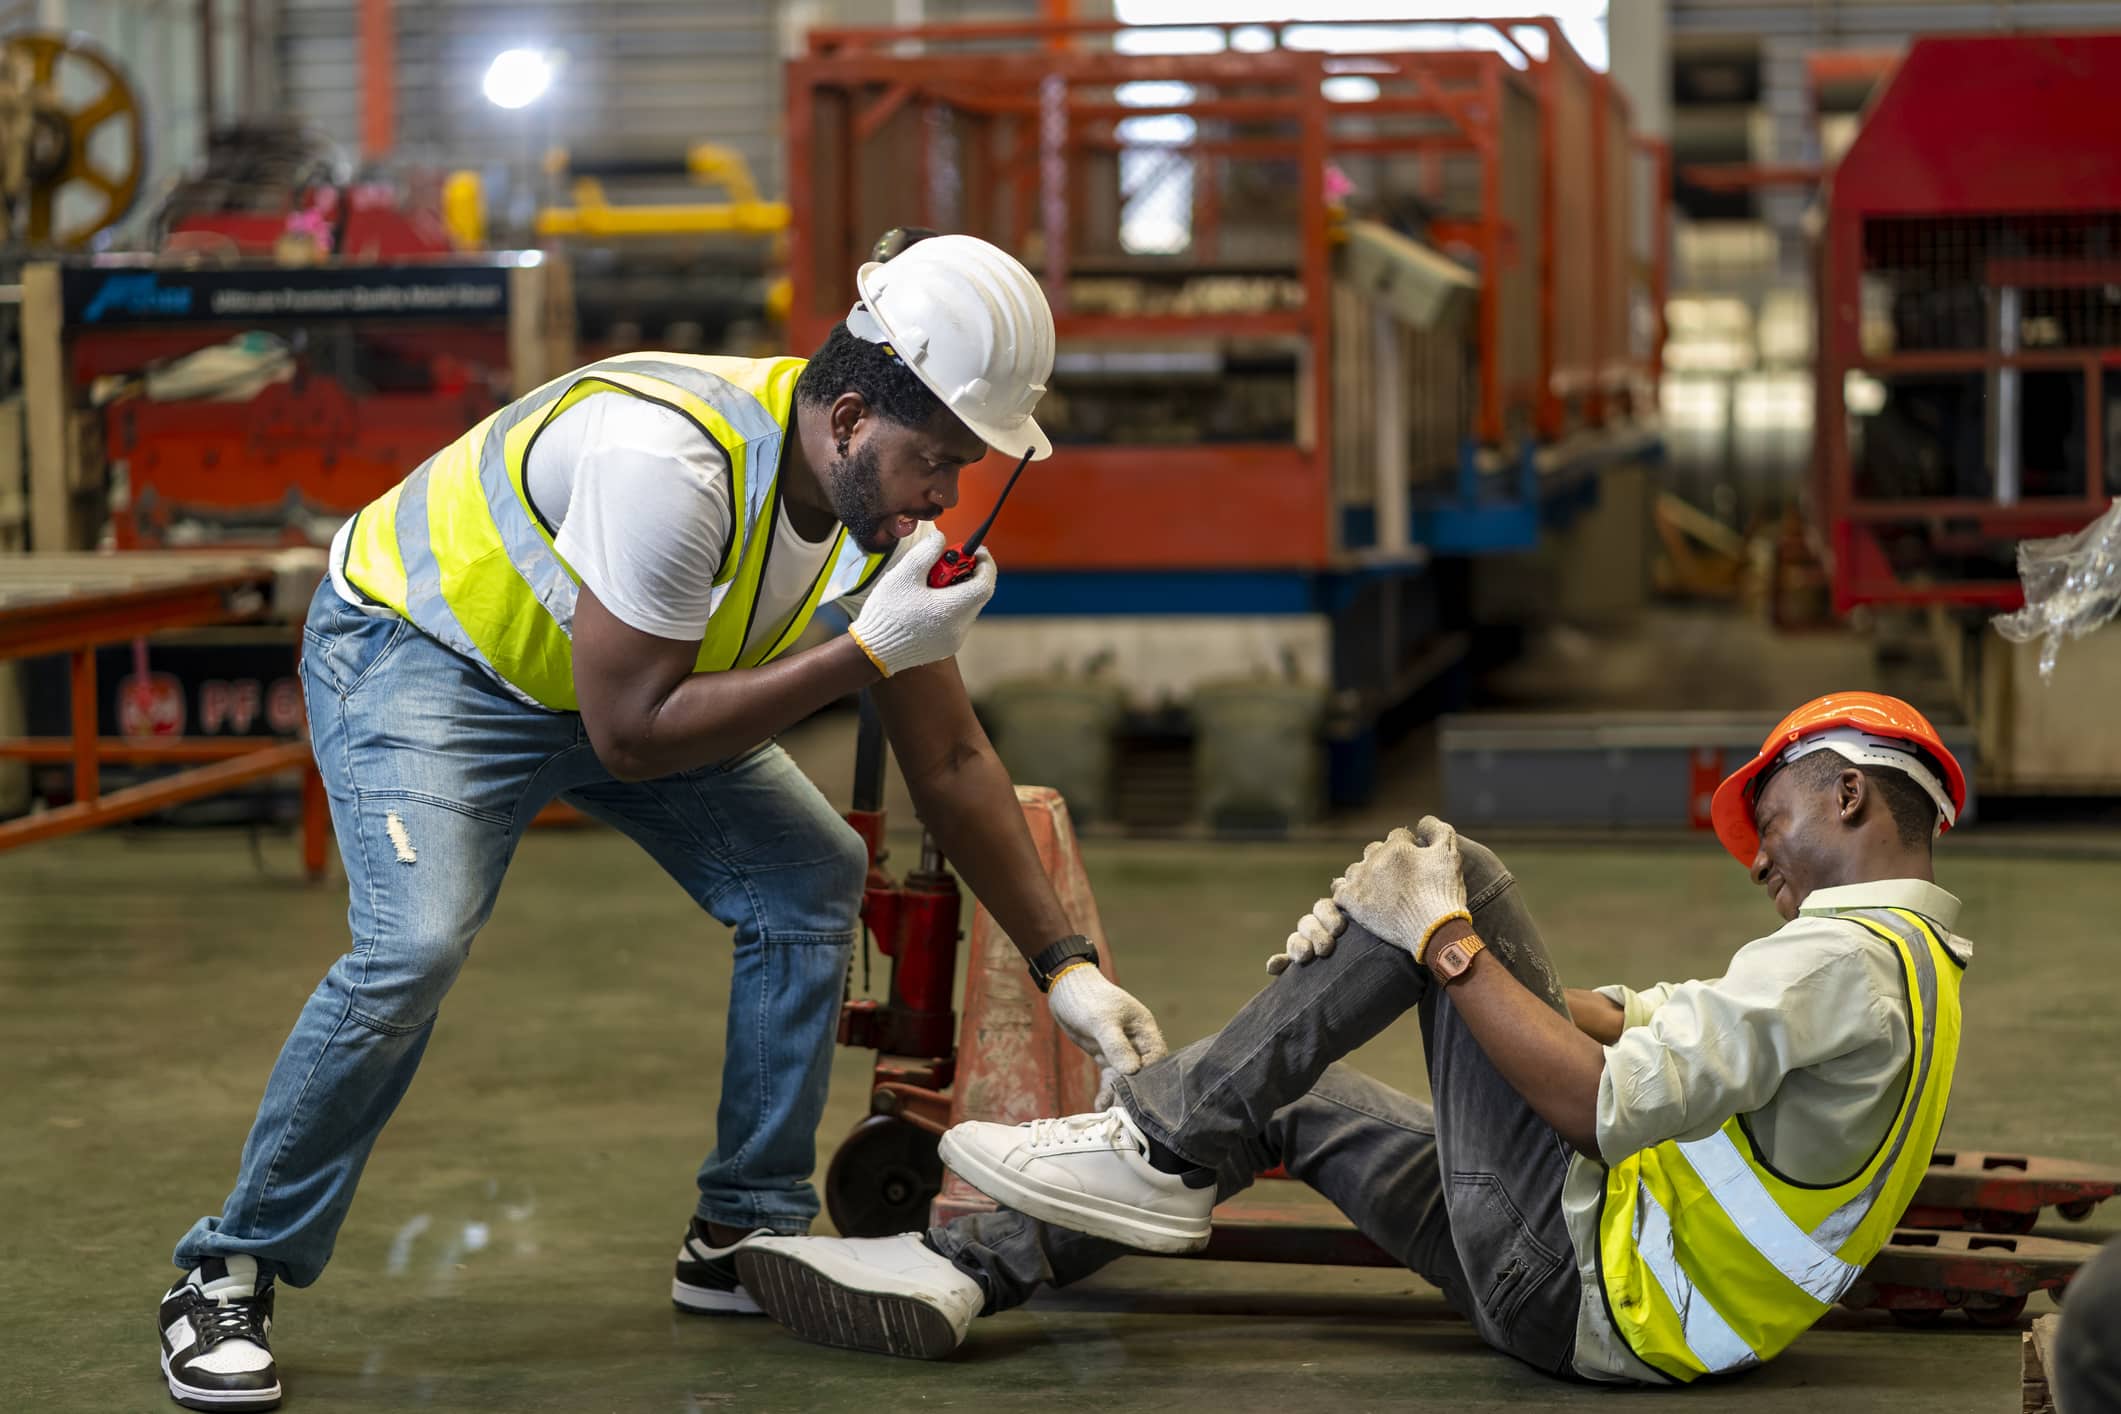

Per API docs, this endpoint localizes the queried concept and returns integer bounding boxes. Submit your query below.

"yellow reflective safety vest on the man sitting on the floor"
[1599,907,1962,1380]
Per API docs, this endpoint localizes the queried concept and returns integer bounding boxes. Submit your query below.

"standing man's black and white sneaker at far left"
[155,1257,280,1410]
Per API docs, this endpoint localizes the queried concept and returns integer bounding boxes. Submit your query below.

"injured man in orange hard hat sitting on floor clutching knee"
[738,693,1968,1382]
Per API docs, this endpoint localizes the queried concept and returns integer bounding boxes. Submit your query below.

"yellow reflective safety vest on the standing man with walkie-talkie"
[341,354,884,712]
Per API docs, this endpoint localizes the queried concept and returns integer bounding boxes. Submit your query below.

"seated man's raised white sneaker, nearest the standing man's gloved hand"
[942,1107,1215,1253]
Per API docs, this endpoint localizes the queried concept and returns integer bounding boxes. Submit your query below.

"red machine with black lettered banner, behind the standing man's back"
[62,121,543,549]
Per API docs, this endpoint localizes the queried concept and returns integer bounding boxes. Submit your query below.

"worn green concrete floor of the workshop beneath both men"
[0,831,2121,1414]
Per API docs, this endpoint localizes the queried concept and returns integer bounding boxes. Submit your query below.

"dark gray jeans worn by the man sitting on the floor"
[929,839,1580,1376]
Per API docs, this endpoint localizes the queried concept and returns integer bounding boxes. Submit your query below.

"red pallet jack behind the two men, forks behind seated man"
[825,767,2121,1327]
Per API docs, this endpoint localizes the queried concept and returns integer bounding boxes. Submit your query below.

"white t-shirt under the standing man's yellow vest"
[331,392,899,665]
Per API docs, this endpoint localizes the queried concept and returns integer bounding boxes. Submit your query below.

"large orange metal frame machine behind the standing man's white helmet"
[787,19,1665,576]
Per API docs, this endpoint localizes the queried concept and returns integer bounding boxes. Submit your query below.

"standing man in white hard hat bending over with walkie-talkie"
[157,235,1164,1410]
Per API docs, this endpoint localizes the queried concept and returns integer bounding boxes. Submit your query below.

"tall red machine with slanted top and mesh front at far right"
[1813,34,2121,611]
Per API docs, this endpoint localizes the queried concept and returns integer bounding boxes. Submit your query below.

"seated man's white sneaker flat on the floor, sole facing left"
[736,1232,986,1361]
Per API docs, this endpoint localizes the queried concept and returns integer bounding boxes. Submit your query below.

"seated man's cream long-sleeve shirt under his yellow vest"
[1561,880,1973,1384]
